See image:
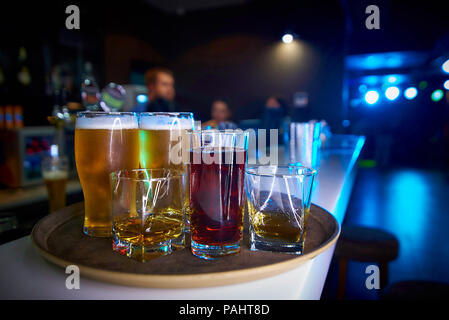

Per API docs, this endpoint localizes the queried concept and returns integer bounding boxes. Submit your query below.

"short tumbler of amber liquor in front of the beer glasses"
[110,169,185,262]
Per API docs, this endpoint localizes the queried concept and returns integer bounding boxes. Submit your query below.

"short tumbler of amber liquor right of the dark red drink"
[245,165,316,254]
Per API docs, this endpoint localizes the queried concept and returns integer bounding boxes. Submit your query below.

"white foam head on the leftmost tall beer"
[76,114,139,130]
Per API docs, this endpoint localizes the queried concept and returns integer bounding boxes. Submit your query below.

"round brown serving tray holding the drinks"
[31,202,340,288]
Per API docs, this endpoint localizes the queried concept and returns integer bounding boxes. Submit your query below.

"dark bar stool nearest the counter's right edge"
[335,226,399,299]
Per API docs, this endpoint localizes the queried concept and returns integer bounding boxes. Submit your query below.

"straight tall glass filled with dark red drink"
[189,130,248,259]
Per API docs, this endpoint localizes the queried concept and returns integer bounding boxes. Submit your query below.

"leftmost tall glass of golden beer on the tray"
[75,111,139,237]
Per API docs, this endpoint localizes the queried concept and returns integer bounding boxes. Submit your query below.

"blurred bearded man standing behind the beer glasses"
[145,67,176,112]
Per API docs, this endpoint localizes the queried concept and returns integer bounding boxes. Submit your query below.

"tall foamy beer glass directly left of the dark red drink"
[139,112,194,242]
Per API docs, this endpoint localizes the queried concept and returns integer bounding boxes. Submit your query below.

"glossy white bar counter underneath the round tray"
[0,135,365,300]
